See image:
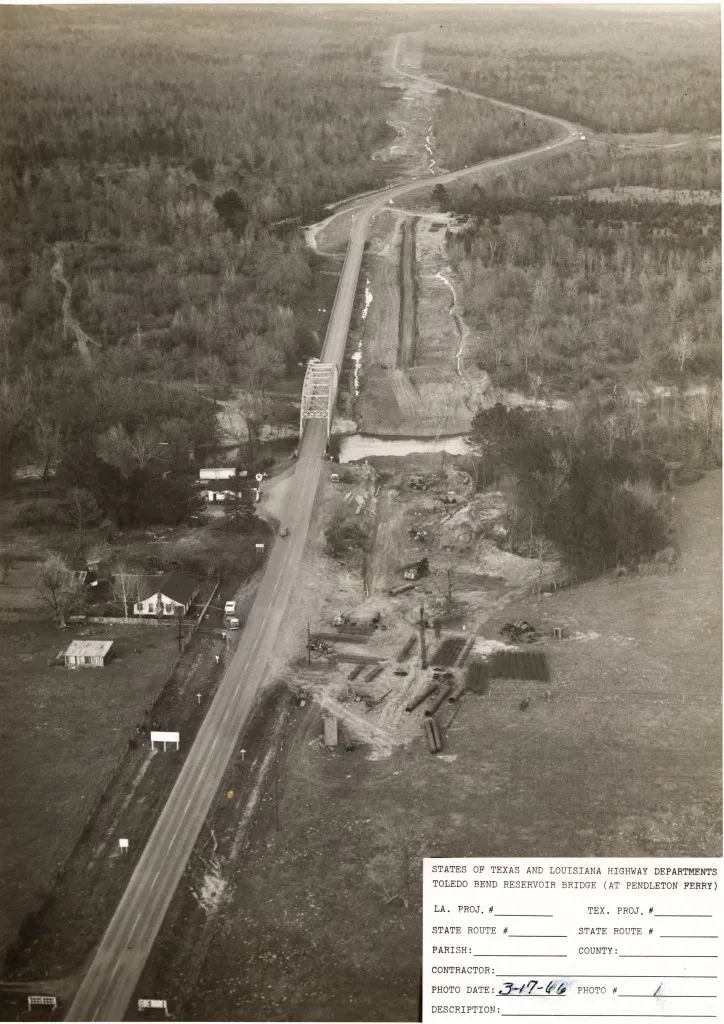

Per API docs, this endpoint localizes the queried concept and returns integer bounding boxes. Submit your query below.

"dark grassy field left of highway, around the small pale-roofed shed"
[0,618,177,953]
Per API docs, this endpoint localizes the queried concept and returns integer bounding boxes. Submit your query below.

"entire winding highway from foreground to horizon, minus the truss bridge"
[66,39,579,1021]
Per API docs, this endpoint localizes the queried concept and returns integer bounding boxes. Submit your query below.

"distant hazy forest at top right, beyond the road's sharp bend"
[423,4,721,133]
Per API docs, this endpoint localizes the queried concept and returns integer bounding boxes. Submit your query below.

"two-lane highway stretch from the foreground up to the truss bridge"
[67,420,327,1021]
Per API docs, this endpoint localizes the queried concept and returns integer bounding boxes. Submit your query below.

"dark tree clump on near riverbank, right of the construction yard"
[472,404,671,575]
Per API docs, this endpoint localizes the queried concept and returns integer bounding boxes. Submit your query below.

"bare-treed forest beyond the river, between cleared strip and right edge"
[436,147,721,409]
